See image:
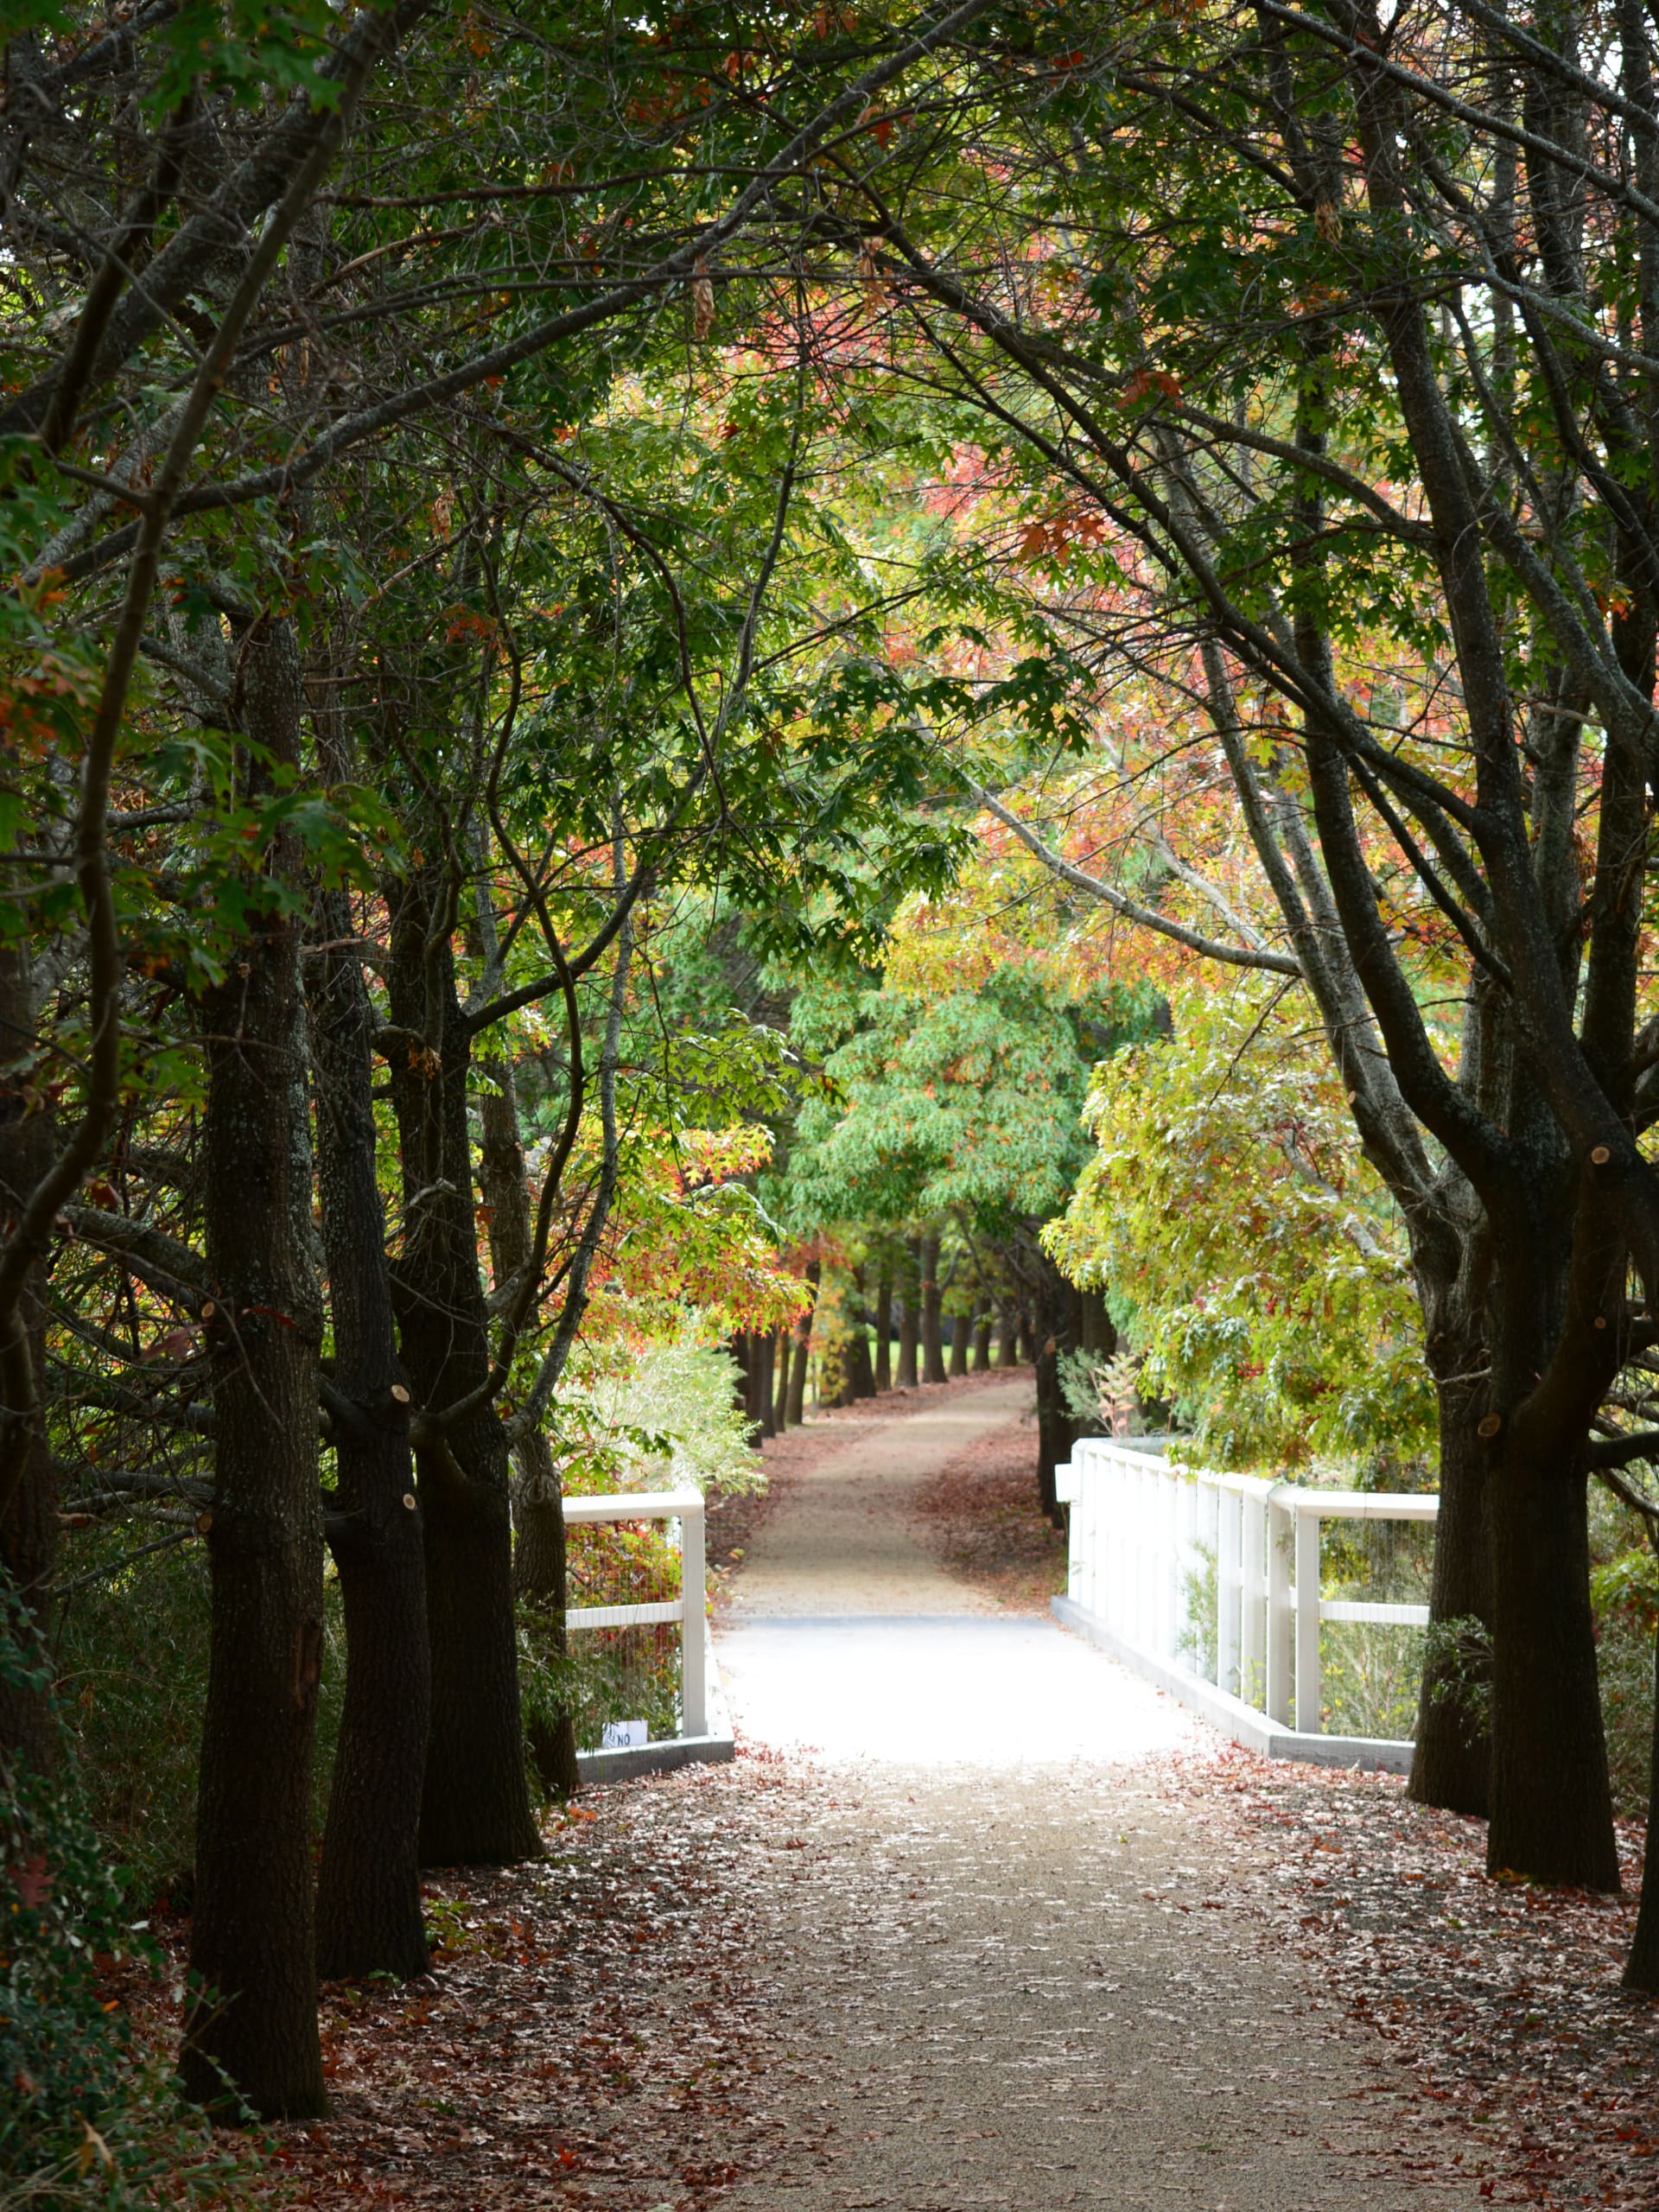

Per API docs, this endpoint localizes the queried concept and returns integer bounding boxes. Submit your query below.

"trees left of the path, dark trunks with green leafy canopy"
[0,4,1035,2141]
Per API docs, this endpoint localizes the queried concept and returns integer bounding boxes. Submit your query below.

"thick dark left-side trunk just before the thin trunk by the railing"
[387,872,540,1867]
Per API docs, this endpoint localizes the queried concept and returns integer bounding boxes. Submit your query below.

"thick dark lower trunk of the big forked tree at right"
[1486,1438,1619,1889]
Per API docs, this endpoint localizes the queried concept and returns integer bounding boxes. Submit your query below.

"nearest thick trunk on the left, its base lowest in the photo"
[181,620,327,2119]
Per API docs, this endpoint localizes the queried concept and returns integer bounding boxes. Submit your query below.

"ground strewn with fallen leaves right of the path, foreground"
[1181,1754,1659,2208]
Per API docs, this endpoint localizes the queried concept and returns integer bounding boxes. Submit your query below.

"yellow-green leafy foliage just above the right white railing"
[1046,978,1433,1482]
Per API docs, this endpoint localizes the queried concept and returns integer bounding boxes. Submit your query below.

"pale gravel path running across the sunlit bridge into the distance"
[710,1378,1476,2212]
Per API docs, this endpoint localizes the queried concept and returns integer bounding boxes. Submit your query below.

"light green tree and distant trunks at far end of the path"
[777,963,1139,1516]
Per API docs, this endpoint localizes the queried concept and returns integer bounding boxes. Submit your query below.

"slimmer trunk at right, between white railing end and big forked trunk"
[1407,1371,1491,1818]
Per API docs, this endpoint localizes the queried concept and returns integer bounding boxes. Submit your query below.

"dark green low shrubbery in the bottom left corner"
[0,1592,245,2212]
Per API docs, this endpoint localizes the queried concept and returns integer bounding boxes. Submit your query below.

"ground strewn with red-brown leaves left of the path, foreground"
[253,1758,827,2212]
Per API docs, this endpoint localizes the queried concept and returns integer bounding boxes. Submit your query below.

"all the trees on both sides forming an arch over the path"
[16,0,1659,2150]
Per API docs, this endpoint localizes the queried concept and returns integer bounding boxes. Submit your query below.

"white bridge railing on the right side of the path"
[1053,1435,1440,1772]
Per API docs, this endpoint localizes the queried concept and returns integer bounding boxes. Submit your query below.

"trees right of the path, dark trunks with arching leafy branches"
[739,0,1659,1980]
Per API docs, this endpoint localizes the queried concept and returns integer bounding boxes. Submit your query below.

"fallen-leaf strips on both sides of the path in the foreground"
[227,1754,1659,2212]
